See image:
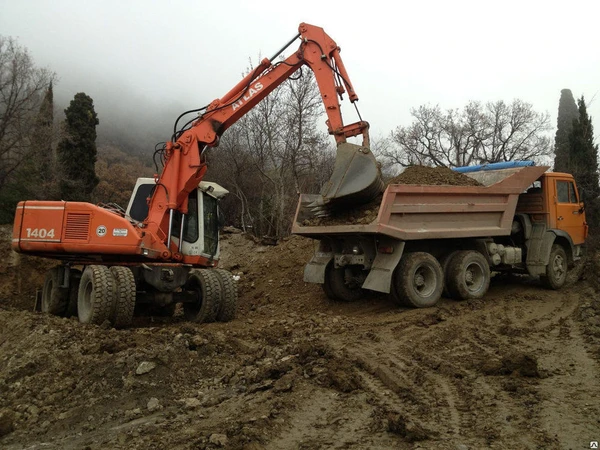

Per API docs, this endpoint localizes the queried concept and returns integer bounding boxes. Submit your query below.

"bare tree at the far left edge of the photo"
[0,36,55,189]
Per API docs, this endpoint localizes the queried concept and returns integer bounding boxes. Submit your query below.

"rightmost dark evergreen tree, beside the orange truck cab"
[569,96,600,226]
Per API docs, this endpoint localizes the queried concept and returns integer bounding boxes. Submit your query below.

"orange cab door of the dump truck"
[555,179,587,245]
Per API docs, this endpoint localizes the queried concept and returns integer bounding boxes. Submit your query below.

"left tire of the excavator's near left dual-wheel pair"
[77,265,115,325]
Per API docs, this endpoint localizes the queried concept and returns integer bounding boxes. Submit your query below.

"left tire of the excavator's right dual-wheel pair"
[183,269,221,323]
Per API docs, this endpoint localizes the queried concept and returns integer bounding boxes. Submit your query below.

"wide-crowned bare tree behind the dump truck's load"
[382,100,552,167]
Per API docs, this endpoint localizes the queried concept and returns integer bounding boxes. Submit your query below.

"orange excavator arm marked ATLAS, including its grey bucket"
[145,23,382,256]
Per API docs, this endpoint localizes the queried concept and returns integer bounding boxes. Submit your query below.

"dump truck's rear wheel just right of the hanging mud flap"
[392,252,444,308]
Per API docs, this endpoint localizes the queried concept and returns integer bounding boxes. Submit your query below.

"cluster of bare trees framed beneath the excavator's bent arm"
[207,72,335,237]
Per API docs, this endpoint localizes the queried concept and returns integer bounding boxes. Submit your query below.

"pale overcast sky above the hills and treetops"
[0,0,600,146]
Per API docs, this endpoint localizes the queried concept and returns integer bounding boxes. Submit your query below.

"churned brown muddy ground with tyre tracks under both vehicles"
[0,229,600,450]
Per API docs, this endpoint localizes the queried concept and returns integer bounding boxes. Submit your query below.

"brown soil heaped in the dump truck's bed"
[302,166,481,227]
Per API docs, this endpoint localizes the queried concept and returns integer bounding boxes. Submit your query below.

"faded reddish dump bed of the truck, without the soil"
[292,166,548,241]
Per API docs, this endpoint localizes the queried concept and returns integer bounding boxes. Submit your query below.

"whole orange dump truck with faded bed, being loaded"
[292,161,588,307]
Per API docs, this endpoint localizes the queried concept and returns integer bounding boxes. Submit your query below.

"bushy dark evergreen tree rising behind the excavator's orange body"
[57,92,99,201]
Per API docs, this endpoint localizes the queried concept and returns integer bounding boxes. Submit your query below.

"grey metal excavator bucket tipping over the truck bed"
[308,143,384,217]
